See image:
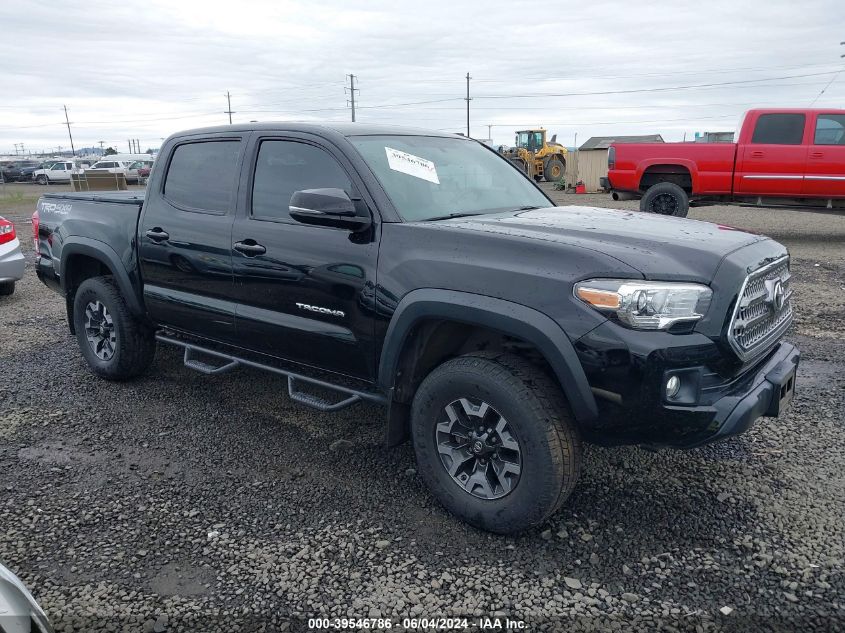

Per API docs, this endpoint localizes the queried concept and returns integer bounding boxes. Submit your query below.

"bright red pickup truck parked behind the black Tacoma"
[602,108,845,216]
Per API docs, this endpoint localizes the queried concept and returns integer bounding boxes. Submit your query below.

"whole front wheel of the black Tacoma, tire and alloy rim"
[411,354,581,534]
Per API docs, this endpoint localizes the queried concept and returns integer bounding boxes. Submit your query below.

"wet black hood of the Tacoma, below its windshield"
[447,206,769,283]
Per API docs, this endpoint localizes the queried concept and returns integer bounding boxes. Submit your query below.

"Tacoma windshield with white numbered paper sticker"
[349,136,553,222]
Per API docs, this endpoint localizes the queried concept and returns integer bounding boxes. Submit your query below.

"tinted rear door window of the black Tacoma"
[164,140,241,215]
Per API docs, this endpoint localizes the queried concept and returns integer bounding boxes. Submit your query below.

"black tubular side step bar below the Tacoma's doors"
[156,333,387,411]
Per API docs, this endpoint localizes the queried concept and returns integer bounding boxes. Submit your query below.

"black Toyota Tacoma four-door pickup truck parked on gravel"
[33,124,799,533]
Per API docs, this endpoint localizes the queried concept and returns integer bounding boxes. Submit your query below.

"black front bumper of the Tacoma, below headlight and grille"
[575,314,800,448]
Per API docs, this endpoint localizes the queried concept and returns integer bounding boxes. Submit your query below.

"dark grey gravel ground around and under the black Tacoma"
[0,181,845,632]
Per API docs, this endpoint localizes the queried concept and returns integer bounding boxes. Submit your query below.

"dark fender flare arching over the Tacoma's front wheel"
[378,288,598,423]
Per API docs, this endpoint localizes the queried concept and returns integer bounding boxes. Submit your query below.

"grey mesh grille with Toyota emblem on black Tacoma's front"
[728,257,792,360]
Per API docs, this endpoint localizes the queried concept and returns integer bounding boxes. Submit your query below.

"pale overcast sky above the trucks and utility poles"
[0,0,845,154]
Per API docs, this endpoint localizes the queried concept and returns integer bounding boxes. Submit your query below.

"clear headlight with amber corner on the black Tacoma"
[575,279,713,330]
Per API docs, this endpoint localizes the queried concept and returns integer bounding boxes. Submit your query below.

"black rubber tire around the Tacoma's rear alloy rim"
[73,277,156,380]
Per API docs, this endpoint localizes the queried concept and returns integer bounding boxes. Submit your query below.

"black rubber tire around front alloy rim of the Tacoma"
[411,354,581,534]
